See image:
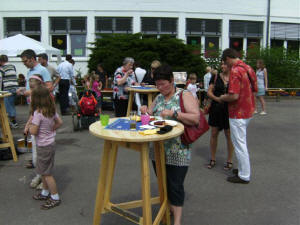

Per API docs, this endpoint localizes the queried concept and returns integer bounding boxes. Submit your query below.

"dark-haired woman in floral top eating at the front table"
[141,65,200,225]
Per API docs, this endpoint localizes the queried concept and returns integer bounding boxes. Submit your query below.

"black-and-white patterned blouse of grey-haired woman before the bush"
[113,67,136,99]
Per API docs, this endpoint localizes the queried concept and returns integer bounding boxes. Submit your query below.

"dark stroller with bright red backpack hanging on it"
[72,90,99,131]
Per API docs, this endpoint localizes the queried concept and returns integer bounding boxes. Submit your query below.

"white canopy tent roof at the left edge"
[0,34,61,58]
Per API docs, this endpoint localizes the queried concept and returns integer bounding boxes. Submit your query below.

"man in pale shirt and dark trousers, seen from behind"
[57,55,74,115]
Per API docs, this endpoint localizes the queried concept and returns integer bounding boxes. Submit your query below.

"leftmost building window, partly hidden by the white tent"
[4,17,41,41]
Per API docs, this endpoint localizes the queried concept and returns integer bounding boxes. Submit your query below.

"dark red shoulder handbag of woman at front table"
[179,92,209,145]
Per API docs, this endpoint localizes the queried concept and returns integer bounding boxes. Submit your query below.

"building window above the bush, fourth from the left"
[141,17,177,37]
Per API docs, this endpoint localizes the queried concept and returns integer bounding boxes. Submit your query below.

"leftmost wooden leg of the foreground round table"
[93,140,112,225]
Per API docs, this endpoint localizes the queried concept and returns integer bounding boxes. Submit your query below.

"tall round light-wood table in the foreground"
[90,118,184,225]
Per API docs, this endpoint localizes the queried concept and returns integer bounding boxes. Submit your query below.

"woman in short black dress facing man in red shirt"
[207,61,233,170]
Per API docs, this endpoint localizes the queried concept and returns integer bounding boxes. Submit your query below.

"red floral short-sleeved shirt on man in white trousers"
[228,60,257,119]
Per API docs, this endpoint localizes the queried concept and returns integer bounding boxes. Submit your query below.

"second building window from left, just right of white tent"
[50,17,87,57]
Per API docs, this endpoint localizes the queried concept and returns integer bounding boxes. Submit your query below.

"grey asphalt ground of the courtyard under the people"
[0,99,300,225]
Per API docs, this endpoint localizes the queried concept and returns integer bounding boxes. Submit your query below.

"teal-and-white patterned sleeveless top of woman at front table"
[150,91,191,166]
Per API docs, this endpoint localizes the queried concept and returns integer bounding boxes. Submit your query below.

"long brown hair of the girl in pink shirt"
[30,85,56,117]
